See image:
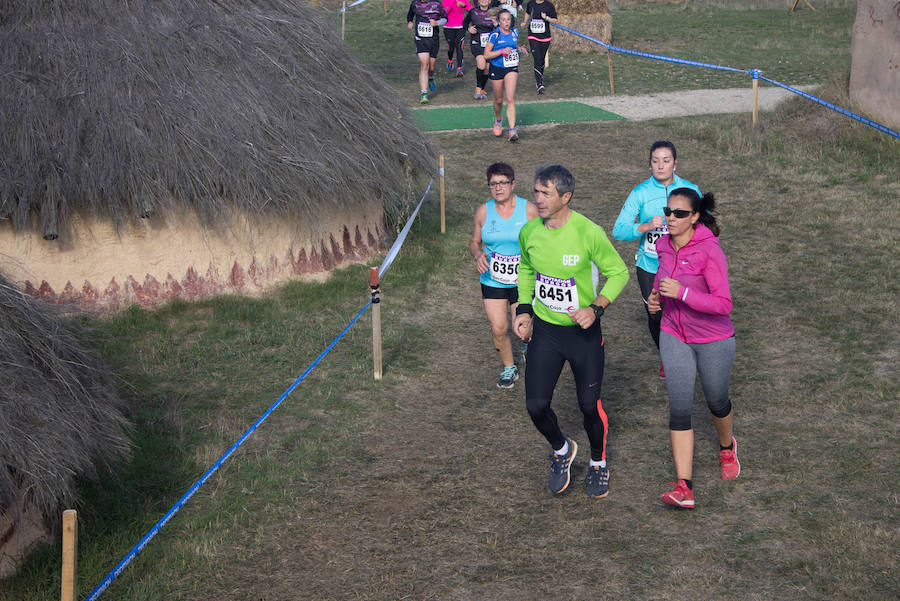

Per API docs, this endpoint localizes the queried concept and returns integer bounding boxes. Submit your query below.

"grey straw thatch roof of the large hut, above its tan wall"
[0,0,435,239]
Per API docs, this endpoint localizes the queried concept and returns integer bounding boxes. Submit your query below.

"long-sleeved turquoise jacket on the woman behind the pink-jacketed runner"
[612,174,700,273]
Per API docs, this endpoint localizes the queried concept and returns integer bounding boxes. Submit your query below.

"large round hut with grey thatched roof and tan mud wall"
[0,0,435,308]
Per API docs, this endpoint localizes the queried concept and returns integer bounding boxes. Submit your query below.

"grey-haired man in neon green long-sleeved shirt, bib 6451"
[514,165,628,498]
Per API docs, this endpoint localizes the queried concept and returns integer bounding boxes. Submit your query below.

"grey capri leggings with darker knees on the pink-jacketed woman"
[659,331,735,430]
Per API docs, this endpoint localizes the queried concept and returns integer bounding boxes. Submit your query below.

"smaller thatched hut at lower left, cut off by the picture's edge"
[0,275,129,578]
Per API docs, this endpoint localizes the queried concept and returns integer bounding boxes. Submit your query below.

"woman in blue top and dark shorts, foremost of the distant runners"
[484,8,519,142]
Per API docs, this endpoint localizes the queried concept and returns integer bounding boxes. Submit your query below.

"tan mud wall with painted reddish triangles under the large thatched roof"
[0,202,385,312]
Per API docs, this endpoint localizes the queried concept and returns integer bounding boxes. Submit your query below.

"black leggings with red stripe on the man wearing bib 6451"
[525,317,608,461]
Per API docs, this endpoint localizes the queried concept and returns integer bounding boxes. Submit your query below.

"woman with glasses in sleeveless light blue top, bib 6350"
[469,163,537,388]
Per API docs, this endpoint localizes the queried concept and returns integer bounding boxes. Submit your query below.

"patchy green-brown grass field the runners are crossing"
[0,0,900,601]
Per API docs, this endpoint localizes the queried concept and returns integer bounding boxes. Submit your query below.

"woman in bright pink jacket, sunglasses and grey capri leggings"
[648,188,741,509]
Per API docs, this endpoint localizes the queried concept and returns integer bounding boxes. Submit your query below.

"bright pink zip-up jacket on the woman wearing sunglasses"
[653,223,734,343]
